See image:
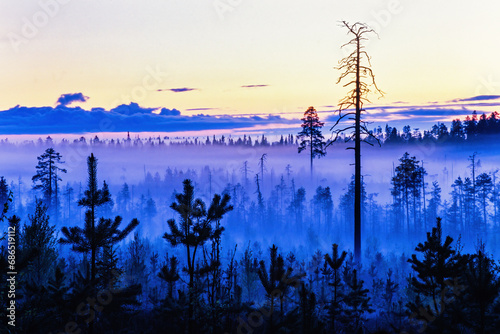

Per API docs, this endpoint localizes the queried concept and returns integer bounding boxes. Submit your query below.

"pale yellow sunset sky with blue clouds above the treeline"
[0,0,500,134]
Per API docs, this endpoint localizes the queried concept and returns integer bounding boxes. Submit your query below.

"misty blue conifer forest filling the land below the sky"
[0,105,500,333]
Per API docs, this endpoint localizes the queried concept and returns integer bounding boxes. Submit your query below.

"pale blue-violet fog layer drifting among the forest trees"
[0,135,500,254]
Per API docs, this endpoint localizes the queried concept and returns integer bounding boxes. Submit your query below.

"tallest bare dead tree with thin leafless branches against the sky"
[331,21,383,262]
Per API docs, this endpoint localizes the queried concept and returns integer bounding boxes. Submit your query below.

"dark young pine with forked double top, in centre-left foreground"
[163,179,233,333]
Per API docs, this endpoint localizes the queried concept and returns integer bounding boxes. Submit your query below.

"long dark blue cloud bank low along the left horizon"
[0,103,299,135]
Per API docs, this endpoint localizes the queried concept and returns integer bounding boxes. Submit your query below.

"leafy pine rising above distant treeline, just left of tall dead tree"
[297,107,326,177]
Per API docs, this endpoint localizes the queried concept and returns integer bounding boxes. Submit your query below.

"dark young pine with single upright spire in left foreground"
[59,153,139,333]
